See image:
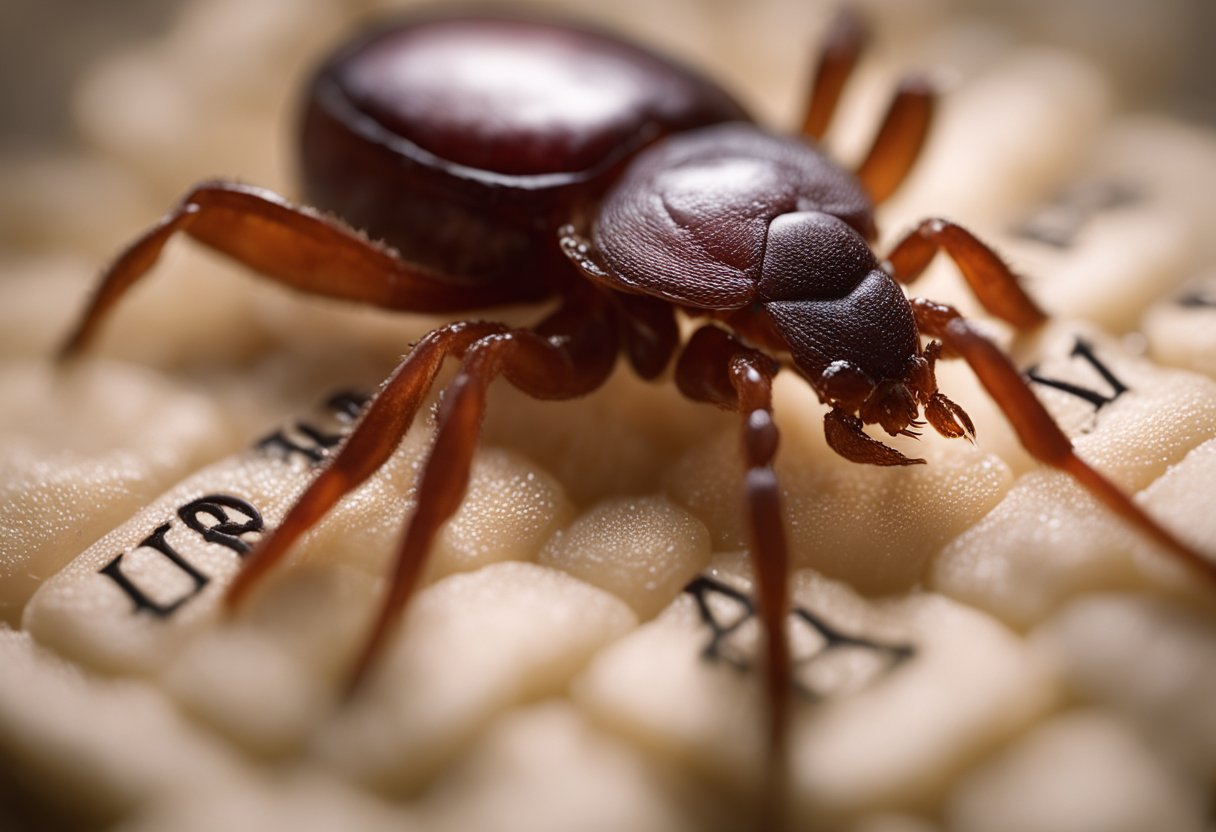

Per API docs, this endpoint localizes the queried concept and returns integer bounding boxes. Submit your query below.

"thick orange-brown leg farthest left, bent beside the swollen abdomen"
[61,181,544,358]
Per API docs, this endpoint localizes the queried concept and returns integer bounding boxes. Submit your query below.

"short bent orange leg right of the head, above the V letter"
[885,219,1047,330]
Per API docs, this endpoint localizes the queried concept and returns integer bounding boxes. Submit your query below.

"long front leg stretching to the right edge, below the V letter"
[912,298,1216,580]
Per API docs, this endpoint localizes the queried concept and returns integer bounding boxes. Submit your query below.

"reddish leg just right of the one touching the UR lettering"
[347,291,617,695]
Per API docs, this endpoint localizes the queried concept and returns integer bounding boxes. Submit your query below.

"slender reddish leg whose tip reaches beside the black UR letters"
[224,322,507,609]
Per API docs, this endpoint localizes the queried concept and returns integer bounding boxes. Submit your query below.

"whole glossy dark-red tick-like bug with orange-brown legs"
[63,13,1216,827]
